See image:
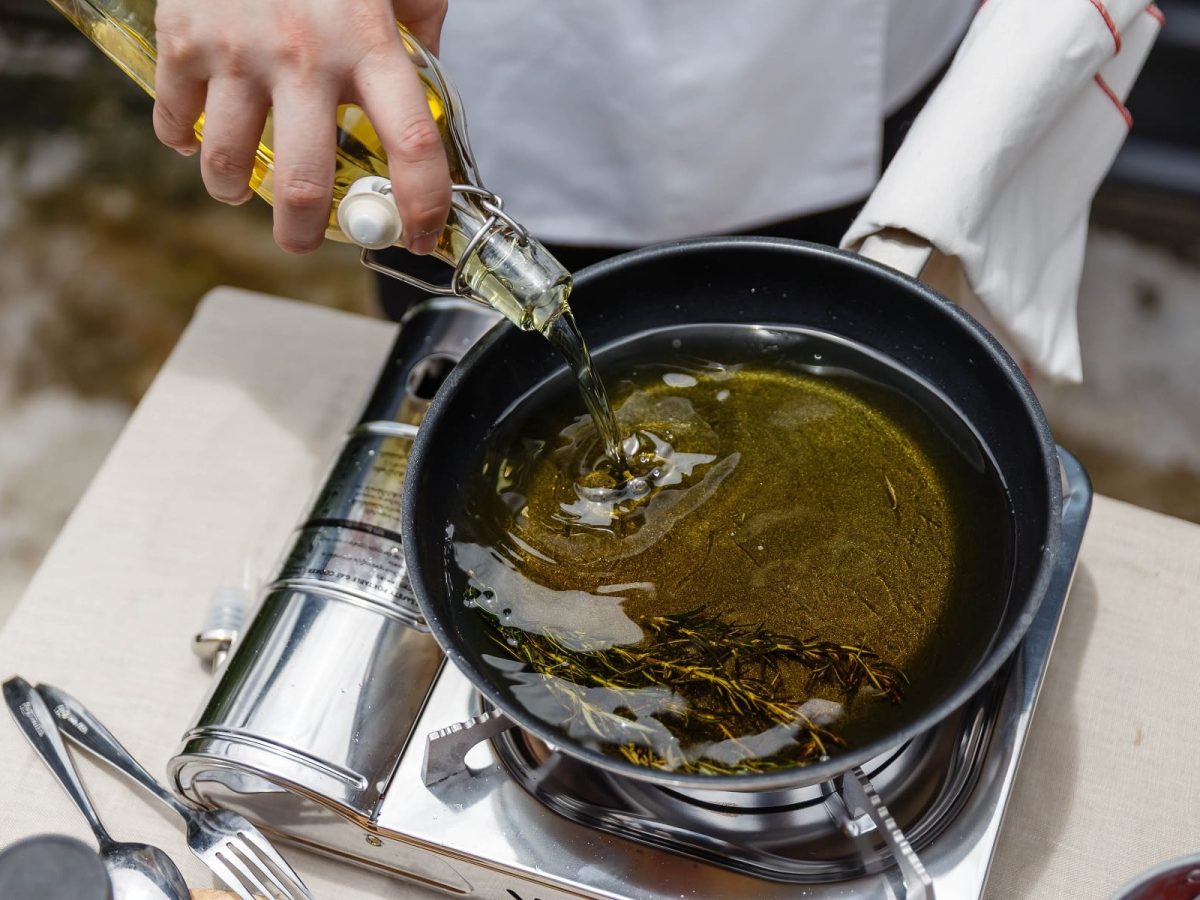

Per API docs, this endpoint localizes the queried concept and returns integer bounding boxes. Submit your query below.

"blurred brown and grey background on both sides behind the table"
[0,0,1200,620]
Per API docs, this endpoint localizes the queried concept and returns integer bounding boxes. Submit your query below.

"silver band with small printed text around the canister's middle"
[280,523,418,611]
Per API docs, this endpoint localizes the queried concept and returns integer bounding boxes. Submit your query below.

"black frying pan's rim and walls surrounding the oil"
[403,238,1062,791]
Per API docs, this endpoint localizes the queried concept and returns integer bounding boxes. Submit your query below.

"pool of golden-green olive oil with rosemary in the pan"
[452,326,1010,774]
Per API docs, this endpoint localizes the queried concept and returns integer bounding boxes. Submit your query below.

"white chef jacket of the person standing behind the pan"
[440,0,978,247]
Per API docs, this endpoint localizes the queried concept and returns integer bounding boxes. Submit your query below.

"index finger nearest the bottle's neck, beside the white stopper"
[355,44,450,253]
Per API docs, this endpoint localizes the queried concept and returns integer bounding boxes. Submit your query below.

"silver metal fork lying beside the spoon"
[37,684,313,900]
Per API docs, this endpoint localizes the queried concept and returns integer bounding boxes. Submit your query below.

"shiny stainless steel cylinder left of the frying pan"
[170,299,499,833]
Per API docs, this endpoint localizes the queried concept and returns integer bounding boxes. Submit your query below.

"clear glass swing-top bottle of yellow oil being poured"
[49,0,571,334]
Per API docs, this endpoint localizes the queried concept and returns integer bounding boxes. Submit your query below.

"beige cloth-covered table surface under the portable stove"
[0,289,1200,900]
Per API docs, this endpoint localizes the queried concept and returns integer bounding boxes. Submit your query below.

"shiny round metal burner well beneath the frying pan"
[436,667,998,884]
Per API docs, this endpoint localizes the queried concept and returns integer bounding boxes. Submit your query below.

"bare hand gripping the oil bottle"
[154,0,450,253]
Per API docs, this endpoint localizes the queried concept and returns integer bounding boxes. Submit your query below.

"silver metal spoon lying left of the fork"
[4,676,191,900]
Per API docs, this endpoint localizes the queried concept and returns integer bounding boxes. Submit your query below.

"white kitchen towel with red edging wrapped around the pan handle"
[842,0,1163,380]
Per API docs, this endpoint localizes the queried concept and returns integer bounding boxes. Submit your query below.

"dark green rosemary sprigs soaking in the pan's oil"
[480,607,905,774]
